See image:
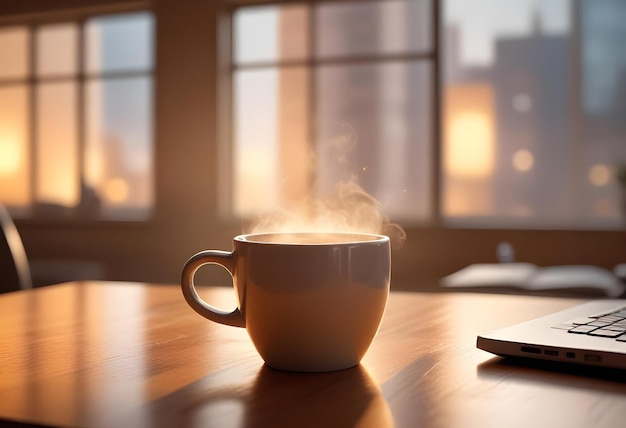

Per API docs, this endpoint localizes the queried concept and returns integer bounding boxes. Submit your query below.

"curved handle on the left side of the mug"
[180,250,246,327]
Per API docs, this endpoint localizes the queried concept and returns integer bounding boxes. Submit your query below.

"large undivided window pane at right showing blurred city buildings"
[442,0,626,227]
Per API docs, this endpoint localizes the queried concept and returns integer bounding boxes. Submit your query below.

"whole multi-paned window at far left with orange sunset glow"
[0,12,154,220]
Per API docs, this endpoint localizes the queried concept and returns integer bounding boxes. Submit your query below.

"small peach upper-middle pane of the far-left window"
[36,24,77,77]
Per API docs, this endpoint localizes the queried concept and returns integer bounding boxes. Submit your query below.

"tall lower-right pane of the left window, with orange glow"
[83,77,153,220]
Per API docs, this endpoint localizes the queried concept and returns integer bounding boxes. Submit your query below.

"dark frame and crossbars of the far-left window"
[0,2,156,225]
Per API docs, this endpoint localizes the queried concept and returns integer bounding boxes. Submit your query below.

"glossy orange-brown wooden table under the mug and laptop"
[0,282,626,428]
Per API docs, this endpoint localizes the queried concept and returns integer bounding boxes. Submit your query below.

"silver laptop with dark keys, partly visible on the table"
[476,299,626,369]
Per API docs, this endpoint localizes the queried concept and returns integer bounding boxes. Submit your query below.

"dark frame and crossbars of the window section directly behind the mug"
[227,0,446,228]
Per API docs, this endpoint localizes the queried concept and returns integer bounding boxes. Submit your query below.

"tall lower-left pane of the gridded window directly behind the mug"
[234,67,313,215]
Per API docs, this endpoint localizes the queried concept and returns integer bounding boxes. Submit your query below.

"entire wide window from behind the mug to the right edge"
[232,0,626,229]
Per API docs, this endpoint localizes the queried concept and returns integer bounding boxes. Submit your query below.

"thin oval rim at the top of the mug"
[233,231,390,246]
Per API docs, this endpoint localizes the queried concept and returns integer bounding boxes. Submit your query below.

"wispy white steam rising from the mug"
[244,124,406,248]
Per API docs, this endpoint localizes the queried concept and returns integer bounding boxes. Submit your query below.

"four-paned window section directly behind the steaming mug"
[233,0,435,226]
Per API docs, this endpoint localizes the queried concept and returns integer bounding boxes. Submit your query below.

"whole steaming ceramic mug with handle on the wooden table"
[181,233,391,372]
